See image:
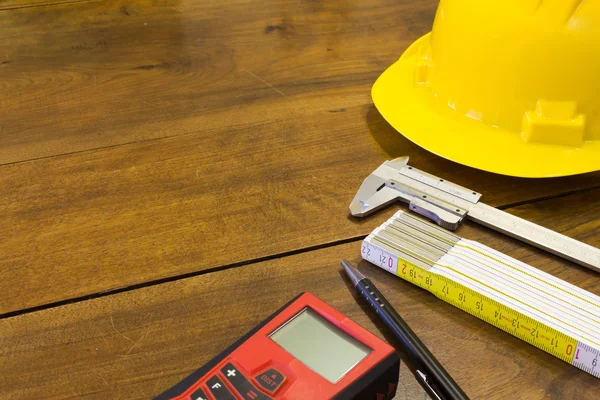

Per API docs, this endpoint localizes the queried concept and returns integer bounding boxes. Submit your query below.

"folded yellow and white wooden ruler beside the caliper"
[362,211,600,378]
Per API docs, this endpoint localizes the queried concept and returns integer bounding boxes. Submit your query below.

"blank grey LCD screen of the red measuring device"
[270,307,371,383]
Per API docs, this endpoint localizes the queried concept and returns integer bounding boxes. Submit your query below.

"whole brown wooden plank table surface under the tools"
[0,0,600,399]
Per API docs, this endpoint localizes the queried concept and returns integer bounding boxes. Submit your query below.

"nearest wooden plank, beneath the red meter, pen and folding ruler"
[0,190,600,399]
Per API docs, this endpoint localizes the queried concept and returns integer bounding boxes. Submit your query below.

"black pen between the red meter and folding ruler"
[342,260,468,400]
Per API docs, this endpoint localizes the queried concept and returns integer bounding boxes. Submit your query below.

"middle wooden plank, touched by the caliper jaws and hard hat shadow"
[0,106,600,314]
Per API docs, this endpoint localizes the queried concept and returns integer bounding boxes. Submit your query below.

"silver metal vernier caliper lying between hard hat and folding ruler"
[350,157,600,272]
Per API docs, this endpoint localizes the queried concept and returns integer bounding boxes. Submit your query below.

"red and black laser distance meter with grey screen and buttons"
[155,293,400,400]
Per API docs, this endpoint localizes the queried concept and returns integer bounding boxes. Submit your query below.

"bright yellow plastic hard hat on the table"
[372,0,600,177]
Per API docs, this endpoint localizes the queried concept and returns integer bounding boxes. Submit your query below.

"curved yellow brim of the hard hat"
[371,34,600,178]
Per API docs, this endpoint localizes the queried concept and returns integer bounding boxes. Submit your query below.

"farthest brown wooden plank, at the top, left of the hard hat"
[0,0,437,163]
